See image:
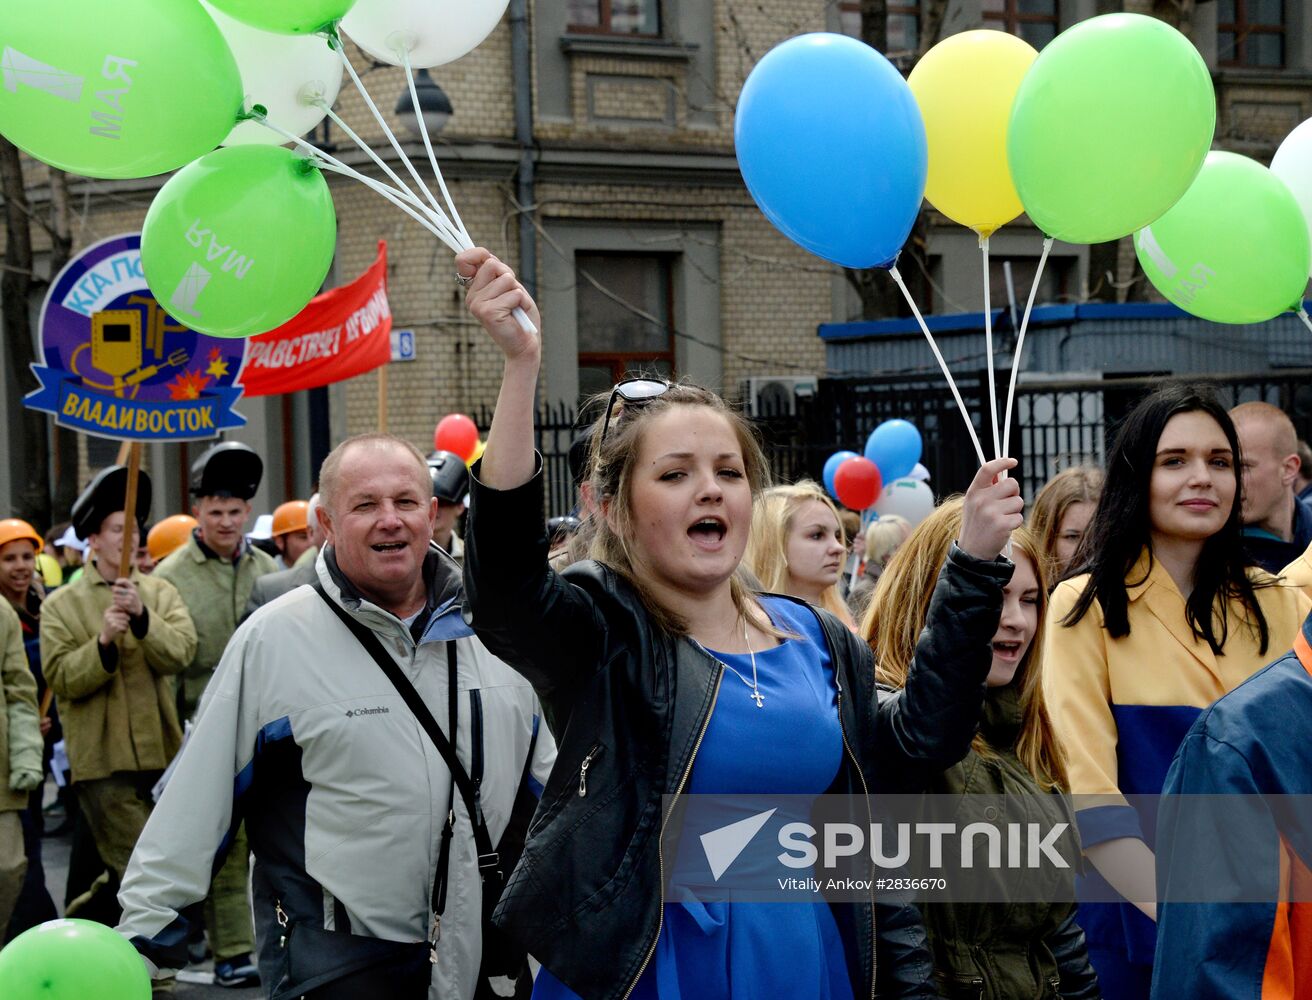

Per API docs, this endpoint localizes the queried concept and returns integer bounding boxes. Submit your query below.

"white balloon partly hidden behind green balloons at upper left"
[202,0,342,146]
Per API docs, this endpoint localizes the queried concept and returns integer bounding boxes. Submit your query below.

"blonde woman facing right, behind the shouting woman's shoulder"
[743,479,857,629]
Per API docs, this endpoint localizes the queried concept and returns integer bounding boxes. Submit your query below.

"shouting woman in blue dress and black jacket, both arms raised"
[458,249,1022,997]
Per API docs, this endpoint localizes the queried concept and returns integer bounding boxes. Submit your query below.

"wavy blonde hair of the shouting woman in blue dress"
[588,382,774,635]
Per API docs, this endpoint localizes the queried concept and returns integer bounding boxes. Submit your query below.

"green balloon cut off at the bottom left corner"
[0,920,151,1000]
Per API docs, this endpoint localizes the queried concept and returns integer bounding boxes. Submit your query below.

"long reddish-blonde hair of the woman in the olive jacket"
[861,496,1067,791]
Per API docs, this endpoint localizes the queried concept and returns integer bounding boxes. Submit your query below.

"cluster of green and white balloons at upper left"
[0,0,508,337]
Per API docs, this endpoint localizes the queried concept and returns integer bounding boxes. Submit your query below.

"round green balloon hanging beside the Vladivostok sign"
[142,146,337,337]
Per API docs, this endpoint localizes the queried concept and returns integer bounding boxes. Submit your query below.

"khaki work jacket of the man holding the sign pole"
[41,566,195,781]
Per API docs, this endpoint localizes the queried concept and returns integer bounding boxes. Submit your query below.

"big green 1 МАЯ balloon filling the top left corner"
[0,0,243,178]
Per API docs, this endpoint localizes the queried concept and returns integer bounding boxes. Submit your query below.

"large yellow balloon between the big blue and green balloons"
[907,30,1039,239]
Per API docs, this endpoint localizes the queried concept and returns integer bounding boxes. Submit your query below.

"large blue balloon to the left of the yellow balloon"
[733,33,929,268]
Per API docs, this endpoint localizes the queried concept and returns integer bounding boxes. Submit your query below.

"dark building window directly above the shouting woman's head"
[575,253,674,399]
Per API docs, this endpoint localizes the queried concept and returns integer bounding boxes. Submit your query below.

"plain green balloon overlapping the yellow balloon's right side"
[1006,14,1216,243]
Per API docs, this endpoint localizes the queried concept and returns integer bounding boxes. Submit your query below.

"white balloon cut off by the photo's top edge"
[341,0,509,70]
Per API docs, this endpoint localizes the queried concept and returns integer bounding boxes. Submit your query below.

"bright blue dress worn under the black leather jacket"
[533,597,853,1000]
